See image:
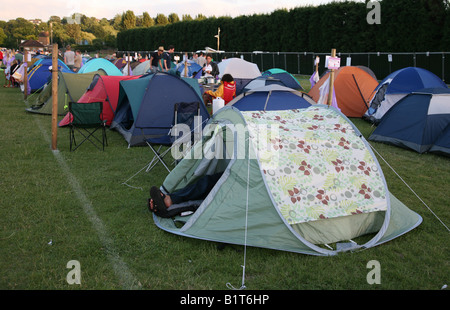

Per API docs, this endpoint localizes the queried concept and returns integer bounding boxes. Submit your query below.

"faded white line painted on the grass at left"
[34,115,140,290]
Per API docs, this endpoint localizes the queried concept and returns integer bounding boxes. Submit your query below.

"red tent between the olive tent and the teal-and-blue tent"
[58,74,139,127]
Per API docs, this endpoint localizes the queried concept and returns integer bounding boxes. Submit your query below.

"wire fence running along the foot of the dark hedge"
[117,51,450,84]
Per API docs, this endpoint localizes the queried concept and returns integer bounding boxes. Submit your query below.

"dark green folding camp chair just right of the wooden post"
[69,102,108,152]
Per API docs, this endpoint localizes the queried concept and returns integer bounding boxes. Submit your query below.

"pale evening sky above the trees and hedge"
[0,0,358,21]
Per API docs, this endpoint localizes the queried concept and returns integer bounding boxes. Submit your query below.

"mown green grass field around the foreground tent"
[0,72,450,296]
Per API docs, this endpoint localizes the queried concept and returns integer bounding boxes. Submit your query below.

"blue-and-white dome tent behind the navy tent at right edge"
[364,67,448,124]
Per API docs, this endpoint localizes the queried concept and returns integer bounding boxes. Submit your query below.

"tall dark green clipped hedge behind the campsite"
[117,0,450,52]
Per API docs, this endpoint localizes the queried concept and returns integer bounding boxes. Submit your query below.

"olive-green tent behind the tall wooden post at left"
[26,70,105,115]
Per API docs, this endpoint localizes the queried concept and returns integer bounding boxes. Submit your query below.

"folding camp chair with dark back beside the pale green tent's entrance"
[142,102,202,172]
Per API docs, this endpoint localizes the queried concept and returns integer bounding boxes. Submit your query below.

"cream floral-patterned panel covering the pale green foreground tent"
[241,106,388,224]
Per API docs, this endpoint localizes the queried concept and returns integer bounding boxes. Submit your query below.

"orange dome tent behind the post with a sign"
[308,66,378,117]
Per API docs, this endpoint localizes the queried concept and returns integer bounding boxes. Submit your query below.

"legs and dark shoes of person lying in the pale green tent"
[148,172,223,218]
